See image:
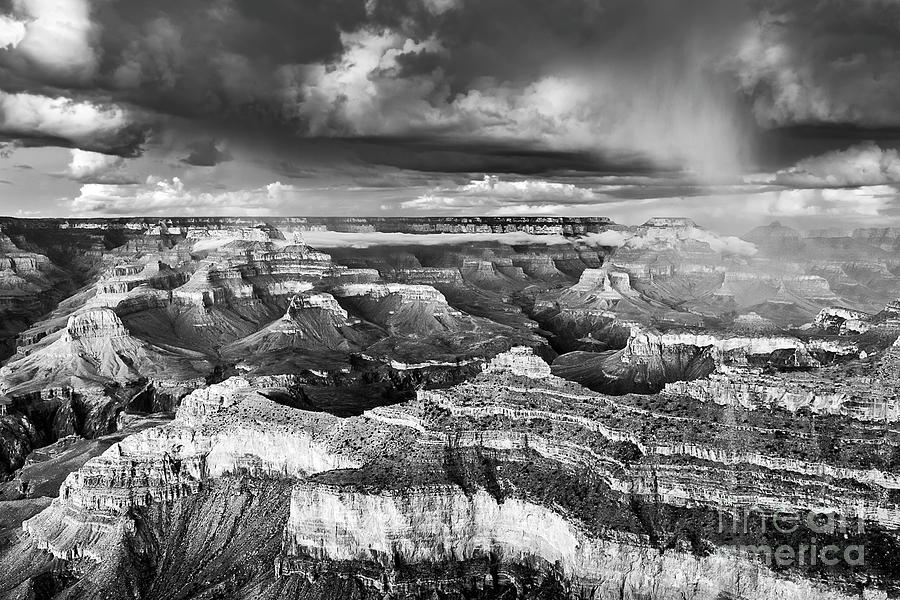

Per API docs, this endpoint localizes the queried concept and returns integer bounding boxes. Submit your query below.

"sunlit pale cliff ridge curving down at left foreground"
[23,379,358,561]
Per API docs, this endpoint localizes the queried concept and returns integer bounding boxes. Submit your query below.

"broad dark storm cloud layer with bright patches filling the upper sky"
[0,0,900,174]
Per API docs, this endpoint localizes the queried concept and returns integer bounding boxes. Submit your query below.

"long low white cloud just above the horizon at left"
[69,176,297,215]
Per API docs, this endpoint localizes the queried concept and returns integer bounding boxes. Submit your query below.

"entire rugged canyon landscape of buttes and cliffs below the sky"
[0,217,900,600]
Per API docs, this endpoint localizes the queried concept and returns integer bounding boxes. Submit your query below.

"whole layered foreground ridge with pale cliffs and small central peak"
[7,348,900,599]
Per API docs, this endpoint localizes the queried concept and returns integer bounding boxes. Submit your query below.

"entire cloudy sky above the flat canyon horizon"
[0,0,900,233]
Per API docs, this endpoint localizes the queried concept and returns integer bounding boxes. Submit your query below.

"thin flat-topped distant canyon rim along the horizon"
[0,217,614,235]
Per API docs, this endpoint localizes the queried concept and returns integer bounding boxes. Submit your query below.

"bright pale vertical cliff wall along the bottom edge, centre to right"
[277,485,848,599]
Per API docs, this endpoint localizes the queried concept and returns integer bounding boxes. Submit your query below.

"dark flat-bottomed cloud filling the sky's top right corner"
[735,0,900,127]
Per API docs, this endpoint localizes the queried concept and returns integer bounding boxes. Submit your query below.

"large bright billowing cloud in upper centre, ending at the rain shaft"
[281,23,744,177]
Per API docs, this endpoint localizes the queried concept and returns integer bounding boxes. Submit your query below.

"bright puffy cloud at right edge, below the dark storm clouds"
[775,142,900,187]
